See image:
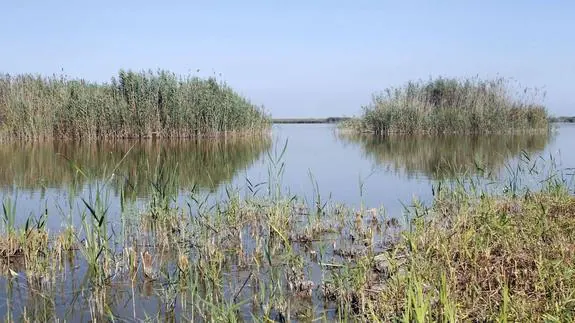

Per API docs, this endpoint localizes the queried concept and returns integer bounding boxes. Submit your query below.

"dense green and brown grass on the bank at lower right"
[379,185,575,322]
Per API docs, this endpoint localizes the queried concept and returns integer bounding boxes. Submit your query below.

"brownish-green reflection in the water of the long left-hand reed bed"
[0,136,271,194]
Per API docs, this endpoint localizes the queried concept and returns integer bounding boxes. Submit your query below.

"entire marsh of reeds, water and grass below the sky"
[0,71,575,322]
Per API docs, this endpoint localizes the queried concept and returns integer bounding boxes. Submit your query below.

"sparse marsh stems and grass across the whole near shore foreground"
[0,153,575,322]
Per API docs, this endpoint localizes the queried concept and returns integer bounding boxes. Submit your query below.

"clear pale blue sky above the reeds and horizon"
[0,0,575,117]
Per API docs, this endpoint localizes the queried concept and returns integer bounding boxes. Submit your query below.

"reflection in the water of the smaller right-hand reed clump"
[338,132,551,179]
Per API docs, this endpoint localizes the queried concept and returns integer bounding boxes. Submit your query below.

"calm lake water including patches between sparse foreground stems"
[0,124,575,321]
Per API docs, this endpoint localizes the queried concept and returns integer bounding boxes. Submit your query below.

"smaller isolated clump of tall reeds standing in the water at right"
[344,78,549,135]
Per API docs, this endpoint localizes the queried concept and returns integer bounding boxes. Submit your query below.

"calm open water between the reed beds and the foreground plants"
[0,124,575,229]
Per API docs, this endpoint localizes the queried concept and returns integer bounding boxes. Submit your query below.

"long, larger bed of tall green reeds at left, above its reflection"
[0,70,271,140]
